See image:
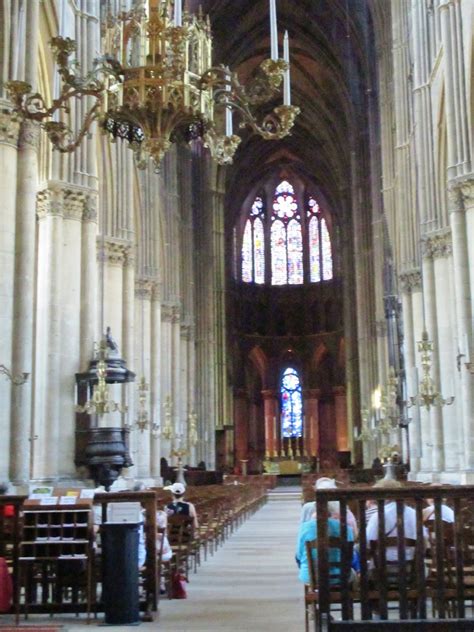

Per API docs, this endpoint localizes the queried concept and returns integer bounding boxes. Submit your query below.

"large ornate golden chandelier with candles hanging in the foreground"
[6,0,299,168]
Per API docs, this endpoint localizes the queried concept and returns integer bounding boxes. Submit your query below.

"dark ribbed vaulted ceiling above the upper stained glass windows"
[191,0,380,226]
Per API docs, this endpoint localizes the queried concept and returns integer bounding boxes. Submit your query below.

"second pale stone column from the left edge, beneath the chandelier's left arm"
[10,121,39,483]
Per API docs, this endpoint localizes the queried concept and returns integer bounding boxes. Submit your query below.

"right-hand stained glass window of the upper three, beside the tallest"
[307,197,333,283]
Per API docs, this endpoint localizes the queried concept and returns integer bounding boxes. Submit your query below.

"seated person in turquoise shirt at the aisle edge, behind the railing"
[295,501,358,584]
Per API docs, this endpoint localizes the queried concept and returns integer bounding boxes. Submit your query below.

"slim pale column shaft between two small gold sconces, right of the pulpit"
[150,283,162,482]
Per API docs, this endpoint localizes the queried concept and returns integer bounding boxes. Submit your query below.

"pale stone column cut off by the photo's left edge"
[0,107,19,481]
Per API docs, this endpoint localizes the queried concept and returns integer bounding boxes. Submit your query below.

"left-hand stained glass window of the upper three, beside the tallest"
[242,197,265,283]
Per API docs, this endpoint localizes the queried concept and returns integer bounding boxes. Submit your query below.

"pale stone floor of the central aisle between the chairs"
[159,488,304,632]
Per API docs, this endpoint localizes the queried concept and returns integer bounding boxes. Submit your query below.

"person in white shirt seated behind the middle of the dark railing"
[366,479,427,562]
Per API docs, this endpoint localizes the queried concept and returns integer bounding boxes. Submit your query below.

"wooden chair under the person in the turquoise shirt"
[304,537,355,632]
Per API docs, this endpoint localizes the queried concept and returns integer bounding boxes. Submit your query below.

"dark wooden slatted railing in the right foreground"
[315,484,474,631]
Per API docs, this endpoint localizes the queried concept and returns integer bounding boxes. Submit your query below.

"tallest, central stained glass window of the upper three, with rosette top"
[271,180,303,285]
